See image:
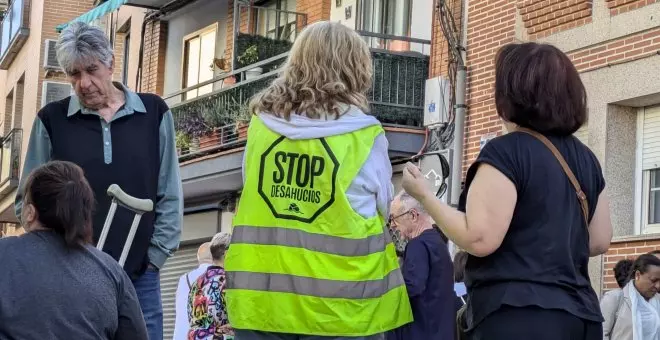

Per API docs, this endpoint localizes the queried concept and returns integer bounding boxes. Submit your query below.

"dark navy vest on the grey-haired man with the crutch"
[38,94,168,278]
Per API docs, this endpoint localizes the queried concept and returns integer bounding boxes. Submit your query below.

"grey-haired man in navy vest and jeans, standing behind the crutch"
[16,22,183,340]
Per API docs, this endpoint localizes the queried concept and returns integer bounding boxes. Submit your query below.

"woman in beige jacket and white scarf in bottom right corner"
[600,254,660,340]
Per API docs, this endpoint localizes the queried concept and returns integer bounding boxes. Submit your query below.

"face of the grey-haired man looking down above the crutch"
[69,60,114,109]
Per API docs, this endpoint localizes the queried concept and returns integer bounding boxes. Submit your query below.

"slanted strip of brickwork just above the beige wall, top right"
[569,27,660,72]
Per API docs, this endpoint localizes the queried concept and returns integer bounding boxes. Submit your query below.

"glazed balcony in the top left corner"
[0,0,30,70]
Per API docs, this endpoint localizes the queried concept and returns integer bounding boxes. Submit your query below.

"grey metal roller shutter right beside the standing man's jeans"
[160,243,201,340]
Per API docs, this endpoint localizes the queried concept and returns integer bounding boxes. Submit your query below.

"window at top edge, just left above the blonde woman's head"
[257,0,297,41]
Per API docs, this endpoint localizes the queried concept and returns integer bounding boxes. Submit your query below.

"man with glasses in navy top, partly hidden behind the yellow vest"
[387,191,456,340]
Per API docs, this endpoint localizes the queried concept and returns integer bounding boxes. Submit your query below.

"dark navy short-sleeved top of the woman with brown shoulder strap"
[459,132,605,328]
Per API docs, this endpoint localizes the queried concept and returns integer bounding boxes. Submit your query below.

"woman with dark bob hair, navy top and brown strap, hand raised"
[403,43,612,340]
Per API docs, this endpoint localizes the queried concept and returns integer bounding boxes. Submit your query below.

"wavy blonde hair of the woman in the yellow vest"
[250,21,373,120]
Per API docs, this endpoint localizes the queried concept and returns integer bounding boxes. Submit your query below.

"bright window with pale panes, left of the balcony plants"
[182,24,218,100]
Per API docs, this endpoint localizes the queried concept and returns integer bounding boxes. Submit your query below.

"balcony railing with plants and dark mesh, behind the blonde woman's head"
[165,33,429,160]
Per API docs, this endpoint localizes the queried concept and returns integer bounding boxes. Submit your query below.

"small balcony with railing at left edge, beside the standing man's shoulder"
[0,129,23,196]
